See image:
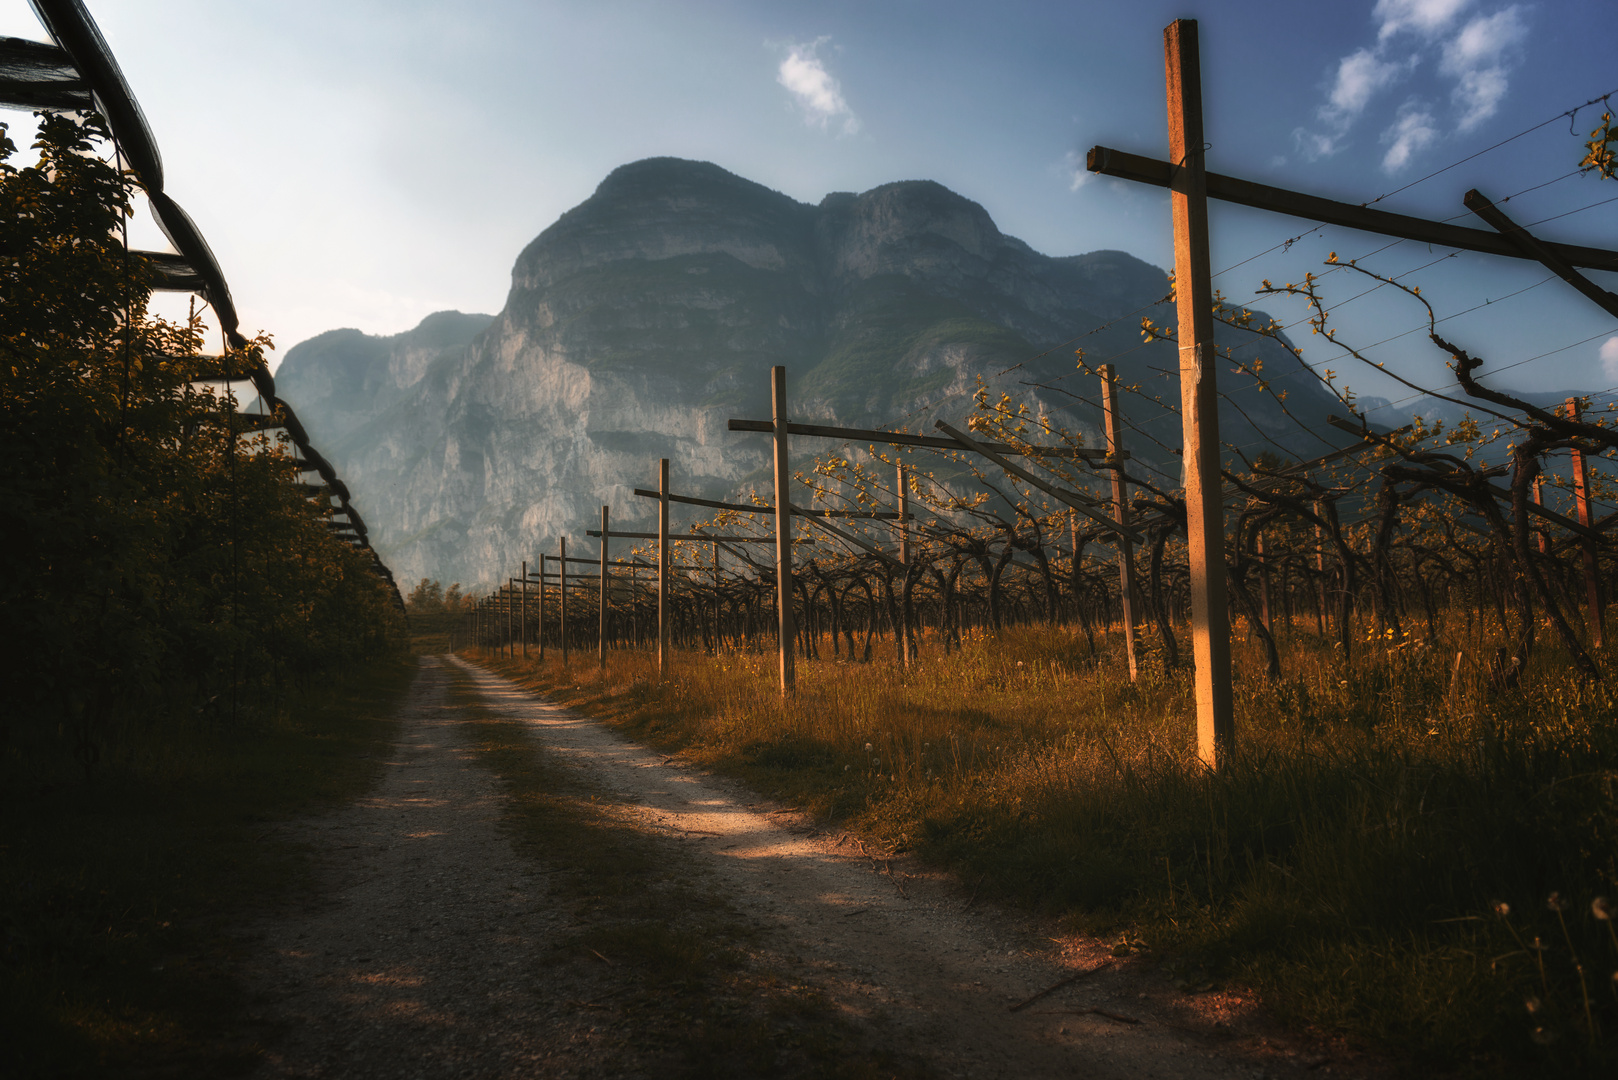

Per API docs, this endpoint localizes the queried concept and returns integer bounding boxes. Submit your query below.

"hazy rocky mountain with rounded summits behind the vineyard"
[277,157,1335,585]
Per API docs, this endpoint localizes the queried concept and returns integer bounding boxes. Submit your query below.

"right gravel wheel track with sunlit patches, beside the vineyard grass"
[445,654,1380,1077]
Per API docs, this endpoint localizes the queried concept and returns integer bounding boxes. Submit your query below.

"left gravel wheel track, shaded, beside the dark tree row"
[246,657,605,1080]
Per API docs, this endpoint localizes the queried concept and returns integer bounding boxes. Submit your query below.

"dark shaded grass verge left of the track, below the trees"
[0,657,414,1080]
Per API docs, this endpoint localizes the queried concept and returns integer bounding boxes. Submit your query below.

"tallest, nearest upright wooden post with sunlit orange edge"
[1163,19,1236,769]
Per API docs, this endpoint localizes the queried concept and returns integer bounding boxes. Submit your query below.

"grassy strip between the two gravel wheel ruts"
[450,663,929,1080]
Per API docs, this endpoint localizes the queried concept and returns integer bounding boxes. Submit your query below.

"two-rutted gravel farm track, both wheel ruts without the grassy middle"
[245,657,1367,1078]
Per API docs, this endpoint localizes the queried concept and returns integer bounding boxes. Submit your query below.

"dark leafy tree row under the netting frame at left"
[0,113,398,769]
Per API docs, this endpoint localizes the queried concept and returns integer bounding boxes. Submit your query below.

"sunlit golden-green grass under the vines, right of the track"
[472,630,1618,1075]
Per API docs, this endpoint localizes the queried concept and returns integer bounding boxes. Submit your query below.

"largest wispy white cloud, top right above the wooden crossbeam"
[1293,0,1527,172]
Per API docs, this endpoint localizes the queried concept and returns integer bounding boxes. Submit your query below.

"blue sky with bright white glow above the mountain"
[0,0,1618,417]
